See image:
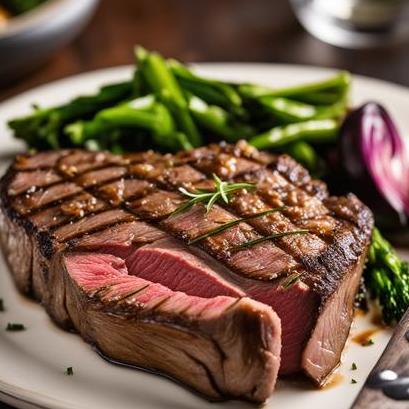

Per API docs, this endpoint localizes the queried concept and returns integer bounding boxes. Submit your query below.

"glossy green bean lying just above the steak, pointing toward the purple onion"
[249,119,339,149]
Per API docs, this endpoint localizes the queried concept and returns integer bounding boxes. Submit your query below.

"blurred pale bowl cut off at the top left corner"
[0,0,98,85]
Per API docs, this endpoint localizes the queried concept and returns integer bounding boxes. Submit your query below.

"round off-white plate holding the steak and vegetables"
[0,64,409,409]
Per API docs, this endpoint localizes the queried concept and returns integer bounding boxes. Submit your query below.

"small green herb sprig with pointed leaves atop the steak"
[171,174,256,216]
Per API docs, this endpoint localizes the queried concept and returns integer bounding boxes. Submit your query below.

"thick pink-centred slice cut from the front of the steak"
[63,253,281,402]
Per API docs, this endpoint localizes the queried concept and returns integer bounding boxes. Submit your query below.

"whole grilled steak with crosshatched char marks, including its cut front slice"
[1,142,373,401]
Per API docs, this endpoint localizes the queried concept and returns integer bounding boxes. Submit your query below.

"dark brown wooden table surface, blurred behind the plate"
[0,0,409,408]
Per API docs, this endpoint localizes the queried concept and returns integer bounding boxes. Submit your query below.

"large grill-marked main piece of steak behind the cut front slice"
[0,142,373,396]
